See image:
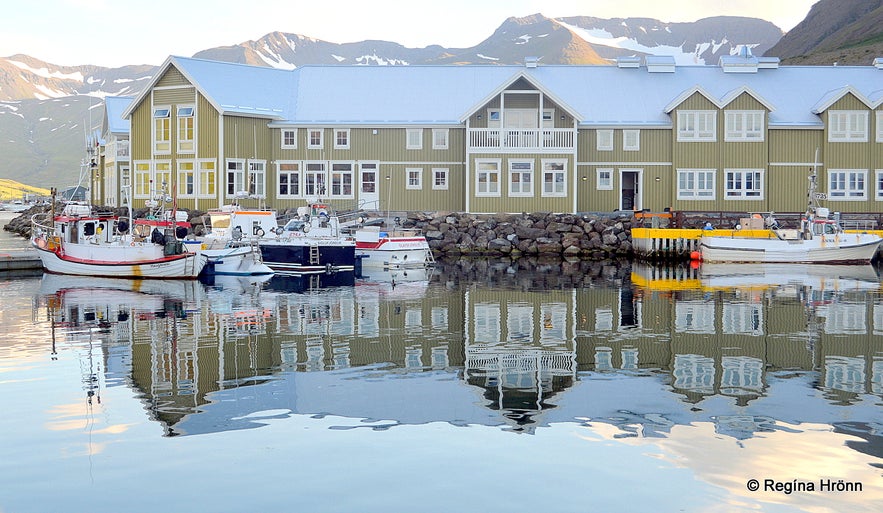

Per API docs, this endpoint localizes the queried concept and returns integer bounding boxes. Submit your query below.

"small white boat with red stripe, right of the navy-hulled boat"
[354,226,435,269]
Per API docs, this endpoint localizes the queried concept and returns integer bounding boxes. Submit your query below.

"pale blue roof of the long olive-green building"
[123,57,883,128]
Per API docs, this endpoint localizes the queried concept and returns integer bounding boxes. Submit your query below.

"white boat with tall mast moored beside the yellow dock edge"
[699,159,883,264]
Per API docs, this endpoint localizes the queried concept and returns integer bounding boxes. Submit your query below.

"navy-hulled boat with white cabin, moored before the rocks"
[258,203,356,275]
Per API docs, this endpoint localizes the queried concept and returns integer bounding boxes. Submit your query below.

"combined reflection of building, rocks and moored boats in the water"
[35,259,883,442]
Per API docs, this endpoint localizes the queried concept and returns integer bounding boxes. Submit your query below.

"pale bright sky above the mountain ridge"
[0,0,818,67]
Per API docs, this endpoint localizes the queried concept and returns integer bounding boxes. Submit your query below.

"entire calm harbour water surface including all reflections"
[0,251,883,513]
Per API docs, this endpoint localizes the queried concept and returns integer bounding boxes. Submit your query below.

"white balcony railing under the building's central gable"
[468,128,576,153]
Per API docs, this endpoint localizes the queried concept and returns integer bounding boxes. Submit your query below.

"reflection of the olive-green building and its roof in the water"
[38,262,883,436]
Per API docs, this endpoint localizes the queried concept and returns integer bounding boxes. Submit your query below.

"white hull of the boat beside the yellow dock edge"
[699,233,883,264]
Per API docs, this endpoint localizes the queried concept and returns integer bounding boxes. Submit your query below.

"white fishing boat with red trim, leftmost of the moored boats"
[31,202,206,278]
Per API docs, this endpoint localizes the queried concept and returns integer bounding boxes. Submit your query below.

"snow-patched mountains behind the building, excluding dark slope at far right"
[0,14,782,186]
